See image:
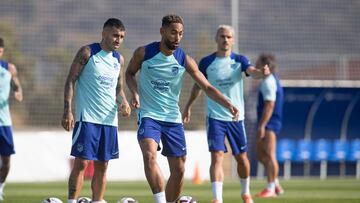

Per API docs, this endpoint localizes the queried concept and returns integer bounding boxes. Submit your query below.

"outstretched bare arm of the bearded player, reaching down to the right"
[186,56,239,120]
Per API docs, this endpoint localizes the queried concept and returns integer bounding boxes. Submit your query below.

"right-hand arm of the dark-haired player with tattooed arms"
[116,55,131,117]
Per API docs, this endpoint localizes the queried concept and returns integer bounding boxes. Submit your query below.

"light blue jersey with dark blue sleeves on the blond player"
[199,53,251,121]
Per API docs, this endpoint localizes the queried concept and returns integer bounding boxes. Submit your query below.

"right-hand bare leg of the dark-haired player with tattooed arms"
[91,161,108,201]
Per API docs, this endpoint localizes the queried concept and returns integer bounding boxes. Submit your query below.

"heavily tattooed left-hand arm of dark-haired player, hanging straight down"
[61,46,91,131]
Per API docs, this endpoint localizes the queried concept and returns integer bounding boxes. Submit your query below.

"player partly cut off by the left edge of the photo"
[0,38,23,201]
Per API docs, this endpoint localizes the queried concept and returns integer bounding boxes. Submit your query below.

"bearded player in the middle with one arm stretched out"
[126,14,238,203]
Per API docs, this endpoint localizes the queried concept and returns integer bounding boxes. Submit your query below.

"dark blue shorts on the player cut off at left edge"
[0,126,15,156]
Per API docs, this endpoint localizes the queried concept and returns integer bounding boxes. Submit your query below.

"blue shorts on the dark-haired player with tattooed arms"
[71,121,119,161]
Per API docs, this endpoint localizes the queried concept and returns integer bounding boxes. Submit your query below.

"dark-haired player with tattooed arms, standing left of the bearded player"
[62,18,131,203]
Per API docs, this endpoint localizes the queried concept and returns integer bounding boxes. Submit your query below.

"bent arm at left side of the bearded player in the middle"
[125,47,145,108]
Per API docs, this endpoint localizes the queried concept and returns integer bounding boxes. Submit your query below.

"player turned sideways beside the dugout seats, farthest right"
[256,54,284,198]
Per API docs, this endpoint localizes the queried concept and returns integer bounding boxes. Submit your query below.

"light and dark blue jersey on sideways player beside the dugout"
[257,74,284,133]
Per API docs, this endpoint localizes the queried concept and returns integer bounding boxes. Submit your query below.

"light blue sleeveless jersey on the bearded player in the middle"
[138,42,186,123]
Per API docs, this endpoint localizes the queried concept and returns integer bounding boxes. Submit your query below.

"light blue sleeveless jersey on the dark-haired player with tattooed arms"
[76,43,121,126]
